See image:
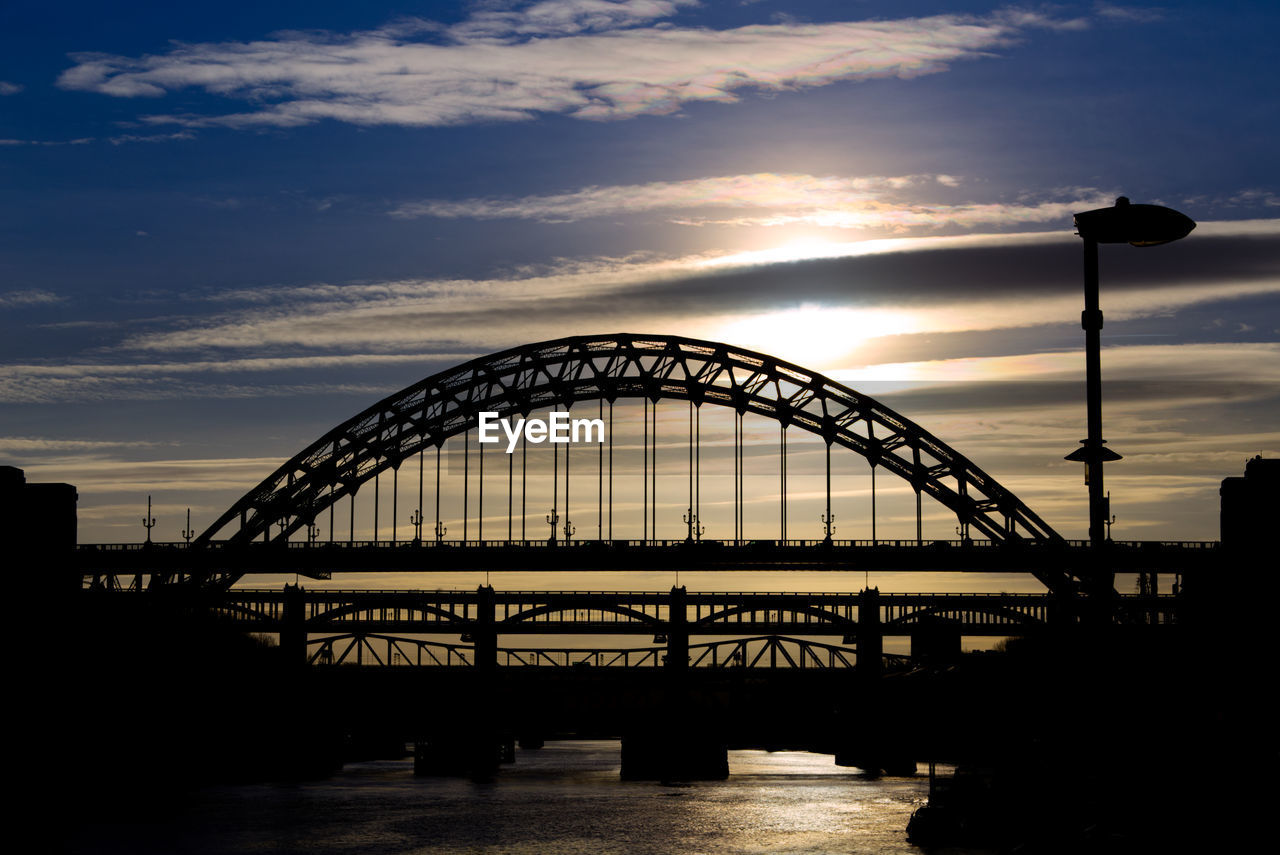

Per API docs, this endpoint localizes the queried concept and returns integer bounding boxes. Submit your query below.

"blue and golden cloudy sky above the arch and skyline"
[0,0,1280,581]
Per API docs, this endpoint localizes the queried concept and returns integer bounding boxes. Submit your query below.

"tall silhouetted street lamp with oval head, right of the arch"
[1066,196,1196,560]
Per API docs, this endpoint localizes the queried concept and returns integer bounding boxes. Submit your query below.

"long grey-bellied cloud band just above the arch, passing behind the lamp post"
[70,221,1280,367]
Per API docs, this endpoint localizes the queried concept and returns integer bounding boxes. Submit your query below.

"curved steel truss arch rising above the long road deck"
[195,334,1079,594]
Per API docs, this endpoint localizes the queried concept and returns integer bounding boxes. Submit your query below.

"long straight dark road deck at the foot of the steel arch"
[73,540,1222,576]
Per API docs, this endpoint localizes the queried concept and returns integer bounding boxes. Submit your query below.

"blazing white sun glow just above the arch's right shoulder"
[716,303,916,369]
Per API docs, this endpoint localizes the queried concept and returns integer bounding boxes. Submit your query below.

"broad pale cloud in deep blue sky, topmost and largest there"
[58,0,1083,128]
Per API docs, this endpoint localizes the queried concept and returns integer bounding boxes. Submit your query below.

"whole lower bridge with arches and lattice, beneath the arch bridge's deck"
[92,585,1179,671]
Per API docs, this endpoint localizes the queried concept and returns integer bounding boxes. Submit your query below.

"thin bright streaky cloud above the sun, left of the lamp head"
[390,173,1116,230]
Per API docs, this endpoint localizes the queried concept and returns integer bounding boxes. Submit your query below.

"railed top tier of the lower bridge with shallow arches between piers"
[102,587,1180,637]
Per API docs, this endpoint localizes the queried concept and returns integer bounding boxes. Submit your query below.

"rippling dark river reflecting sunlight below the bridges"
[62,740,962,855]
